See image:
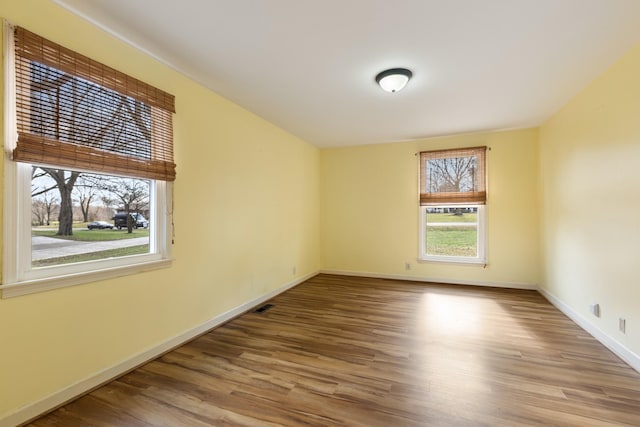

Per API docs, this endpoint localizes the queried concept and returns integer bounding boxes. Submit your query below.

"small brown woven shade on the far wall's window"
[420,147,487,206]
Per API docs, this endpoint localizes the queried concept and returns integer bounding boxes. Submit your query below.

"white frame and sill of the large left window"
[0,22,173,298]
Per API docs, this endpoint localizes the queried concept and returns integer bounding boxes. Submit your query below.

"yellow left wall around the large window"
[0,0,320,424]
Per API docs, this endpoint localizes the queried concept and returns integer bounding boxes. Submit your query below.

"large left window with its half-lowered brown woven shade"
[0,25,175,297]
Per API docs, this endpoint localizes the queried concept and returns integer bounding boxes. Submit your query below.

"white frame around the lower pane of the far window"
[418,205,487,265]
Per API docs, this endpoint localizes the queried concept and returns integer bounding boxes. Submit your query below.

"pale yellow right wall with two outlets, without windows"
[540,45,640,355]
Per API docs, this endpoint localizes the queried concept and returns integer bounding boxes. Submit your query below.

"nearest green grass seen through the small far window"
[427,227,478,257]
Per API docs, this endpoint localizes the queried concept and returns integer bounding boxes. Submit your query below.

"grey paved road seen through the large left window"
[31,236,149,261]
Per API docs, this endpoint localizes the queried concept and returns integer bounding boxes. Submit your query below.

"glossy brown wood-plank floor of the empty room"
[27,275,640,427]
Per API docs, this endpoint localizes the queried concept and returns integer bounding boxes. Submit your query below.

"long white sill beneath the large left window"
[0,259,172,299]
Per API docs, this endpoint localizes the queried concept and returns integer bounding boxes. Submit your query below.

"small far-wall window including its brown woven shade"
[419,147,487,264]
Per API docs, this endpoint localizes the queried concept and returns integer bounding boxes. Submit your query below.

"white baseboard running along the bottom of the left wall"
[0,272,318,427]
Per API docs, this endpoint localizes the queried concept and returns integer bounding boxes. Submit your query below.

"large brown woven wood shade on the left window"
[13,27,175,181]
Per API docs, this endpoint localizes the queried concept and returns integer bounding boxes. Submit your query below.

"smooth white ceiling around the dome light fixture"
[55,0,640,147]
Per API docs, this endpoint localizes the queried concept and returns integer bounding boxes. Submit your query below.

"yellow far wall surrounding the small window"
[320,129,539,286]
